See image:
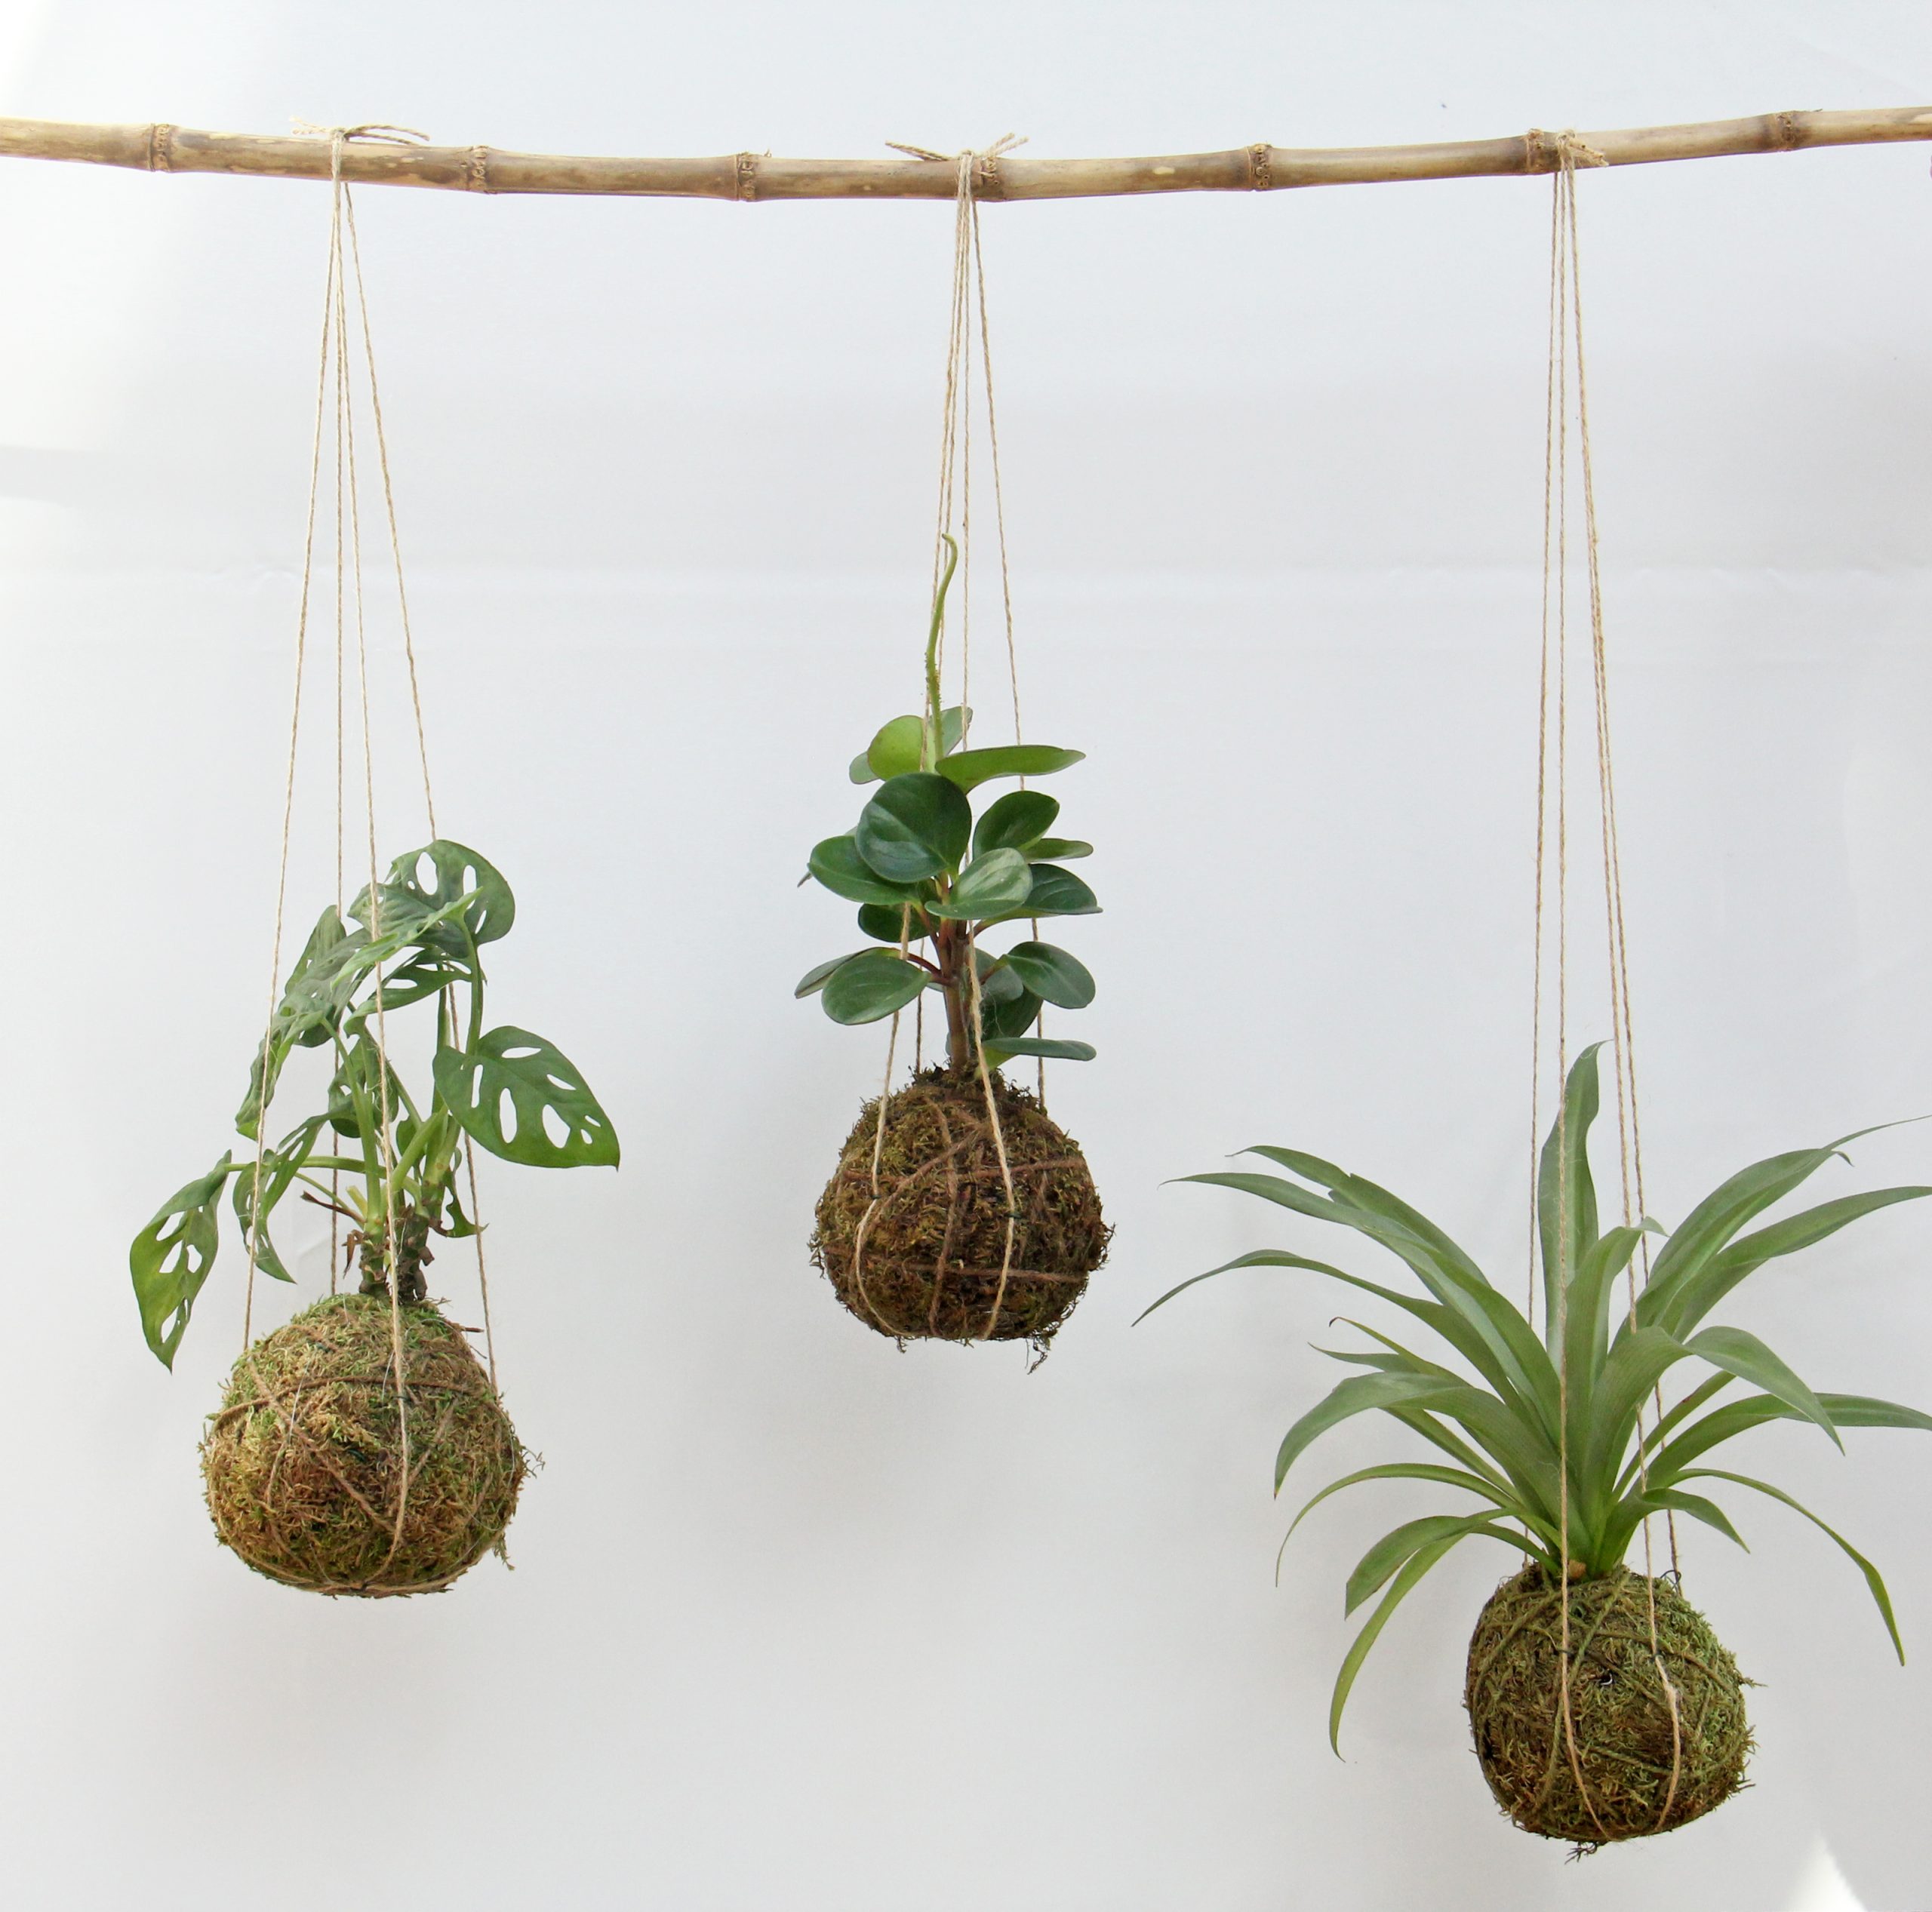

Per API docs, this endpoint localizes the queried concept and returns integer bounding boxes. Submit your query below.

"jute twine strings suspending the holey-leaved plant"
[242,120,497,1582]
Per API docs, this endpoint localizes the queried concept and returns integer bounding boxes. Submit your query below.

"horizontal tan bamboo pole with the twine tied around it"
[0,106,1932,201]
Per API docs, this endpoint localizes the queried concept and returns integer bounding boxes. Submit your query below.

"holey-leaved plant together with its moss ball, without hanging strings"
[130,840,618,1595]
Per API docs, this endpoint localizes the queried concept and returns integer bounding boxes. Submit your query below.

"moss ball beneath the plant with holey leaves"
[201,1294,525,1597]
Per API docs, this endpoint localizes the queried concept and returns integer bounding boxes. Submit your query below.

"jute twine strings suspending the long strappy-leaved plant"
[1528,131,1683,1837]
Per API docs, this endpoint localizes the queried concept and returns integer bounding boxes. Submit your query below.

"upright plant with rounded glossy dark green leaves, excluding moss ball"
[796,539,1100,1070]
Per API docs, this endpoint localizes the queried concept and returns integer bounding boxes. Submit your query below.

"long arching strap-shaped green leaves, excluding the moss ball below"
[1148,1049,1932,1738]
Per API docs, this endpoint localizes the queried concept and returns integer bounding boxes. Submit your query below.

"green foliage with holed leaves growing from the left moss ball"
[128,838,618,1367]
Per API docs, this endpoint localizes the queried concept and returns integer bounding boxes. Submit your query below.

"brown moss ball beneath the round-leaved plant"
[811,1068,1113,1352]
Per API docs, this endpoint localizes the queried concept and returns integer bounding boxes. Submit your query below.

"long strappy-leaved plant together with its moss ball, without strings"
[1149,1049,1932,1849]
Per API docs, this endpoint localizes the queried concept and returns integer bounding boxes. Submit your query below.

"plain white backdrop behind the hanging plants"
[0,0,1932,1912]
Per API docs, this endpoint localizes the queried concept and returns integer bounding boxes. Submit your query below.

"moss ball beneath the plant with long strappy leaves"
[1464,1564,1750,1850]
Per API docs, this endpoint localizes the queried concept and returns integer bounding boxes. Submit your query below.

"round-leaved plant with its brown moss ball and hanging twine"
[796,139,1111,1356]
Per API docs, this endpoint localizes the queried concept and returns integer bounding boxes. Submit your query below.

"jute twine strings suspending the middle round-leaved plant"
[852,134,1048,1346]
